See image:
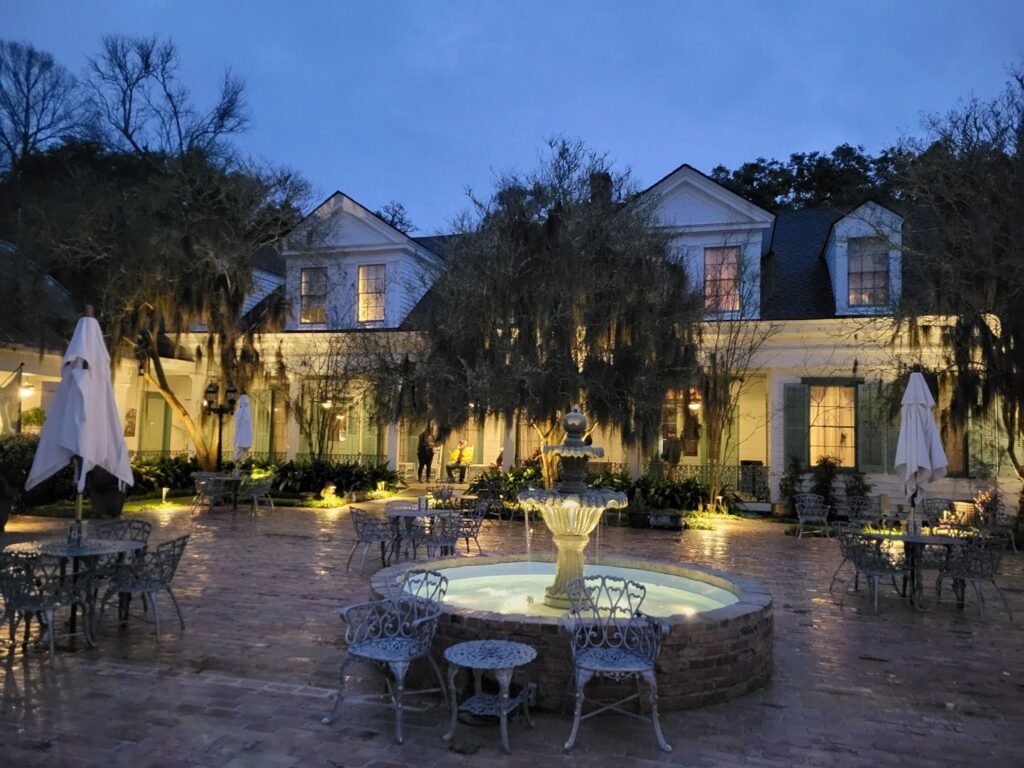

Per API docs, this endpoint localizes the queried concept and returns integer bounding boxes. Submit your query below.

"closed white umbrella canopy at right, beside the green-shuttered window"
[896,371,947,506]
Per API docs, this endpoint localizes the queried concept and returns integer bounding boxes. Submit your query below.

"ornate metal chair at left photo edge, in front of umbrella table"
[0,553,96,665]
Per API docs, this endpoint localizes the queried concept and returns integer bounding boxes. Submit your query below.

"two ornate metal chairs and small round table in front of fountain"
[323,569,672,753]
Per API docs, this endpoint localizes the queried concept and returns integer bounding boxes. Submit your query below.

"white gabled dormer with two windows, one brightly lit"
[283,191,438,331]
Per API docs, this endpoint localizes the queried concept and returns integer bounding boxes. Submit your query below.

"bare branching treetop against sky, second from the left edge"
[87,35,249,155]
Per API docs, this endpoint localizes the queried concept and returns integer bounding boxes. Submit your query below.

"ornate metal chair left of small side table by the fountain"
[321,570,447,744]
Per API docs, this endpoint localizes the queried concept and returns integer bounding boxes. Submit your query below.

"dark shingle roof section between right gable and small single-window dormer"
[761,209,844,319]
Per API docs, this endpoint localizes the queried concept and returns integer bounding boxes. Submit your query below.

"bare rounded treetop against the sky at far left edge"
[0,41,82,167]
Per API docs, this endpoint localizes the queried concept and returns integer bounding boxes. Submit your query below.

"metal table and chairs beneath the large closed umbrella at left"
[0,518,188,664]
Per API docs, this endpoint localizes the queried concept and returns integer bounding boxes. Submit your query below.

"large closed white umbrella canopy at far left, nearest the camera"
[25,316,134,494]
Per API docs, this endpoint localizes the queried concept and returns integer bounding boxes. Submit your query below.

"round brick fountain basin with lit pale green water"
[372,557,774,710]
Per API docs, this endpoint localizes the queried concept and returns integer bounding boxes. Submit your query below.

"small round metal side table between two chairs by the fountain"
[442,640,537,753]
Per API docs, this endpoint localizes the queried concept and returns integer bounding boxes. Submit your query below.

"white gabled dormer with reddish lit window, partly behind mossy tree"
[643,165,774,319]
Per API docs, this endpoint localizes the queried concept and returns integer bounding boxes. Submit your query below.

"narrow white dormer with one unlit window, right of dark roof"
[824,201,903,316]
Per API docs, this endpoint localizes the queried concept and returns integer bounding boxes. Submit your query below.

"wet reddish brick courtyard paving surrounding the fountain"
[0,499,1024,768]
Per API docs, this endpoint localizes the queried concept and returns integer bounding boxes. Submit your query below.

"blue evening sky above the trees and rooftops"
[8,0,1024,233]
